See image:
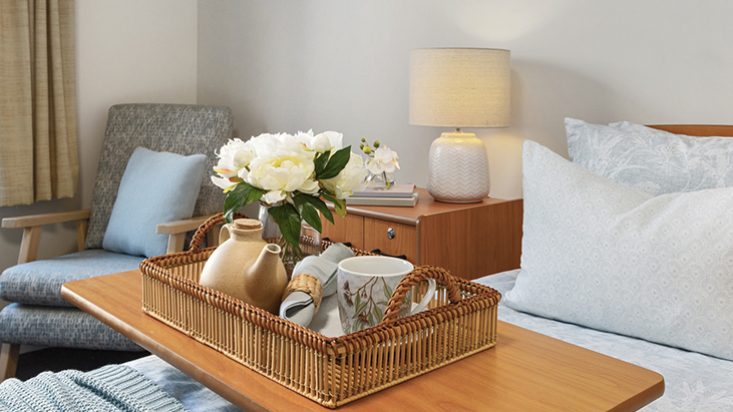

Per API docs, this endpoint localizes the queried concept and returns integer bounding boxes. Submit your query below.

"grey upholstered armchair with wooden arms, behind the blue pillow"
[0,104,232,381]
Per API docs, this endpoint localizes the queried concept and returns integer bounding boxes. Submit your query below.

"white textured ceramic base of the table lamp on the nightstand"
[428,132,489,203]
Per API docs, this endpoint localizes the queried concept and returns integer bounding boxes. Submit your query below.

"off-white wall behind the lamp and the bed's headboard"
[198,0,733,197]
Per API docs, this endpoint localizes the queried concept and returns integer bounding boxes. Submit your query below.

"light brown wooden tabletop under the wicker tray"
[61,270,664,411]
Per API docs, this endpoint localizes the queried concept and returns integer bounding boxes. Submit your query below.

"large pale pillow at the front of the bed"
[506,141,733,360]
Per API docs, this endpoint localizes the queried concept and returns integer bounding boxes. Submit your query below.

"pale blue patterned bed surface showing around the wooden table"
[128,270,733,412]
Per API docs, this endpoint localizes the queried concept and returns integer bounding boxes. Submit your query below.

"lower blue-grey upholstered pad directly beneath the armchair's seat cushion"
[0,303,142,351]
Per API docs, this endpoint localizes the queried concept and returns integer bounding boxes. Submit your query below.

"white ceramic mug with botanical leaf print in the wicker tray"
[337,256,436,334]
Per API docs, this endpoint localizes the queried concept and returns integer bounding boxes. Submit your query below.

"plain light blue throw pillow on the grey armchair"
[102,147,206,257]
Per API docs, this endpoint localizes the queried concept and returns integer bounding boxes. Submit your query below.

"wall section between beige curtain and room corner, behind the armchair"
[0,0,197,280]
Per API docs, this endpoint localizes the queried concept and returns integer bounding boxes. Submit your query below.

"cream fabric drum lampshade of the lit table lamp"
[410,48,511,127]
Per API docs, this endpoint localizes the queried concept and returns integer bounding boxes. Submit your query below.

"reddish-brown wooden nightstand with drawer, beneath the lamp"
[322,189,523,279]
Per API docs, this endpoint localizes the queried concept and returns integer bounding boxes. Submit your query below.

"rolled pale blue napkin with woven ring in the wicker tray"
[280,243,354,327]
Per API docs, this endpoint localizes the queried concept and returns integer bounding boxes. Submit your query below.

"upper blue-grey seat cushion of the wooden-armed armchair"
[0,249,142,306]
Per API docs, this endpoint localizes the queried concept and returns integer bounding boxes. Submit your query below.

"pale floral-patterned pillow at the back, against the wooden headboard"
[565,118,733,195]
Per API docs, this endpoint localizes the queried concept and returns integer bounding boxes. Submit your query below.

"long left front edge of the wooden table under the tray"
[61,284,268,412]
